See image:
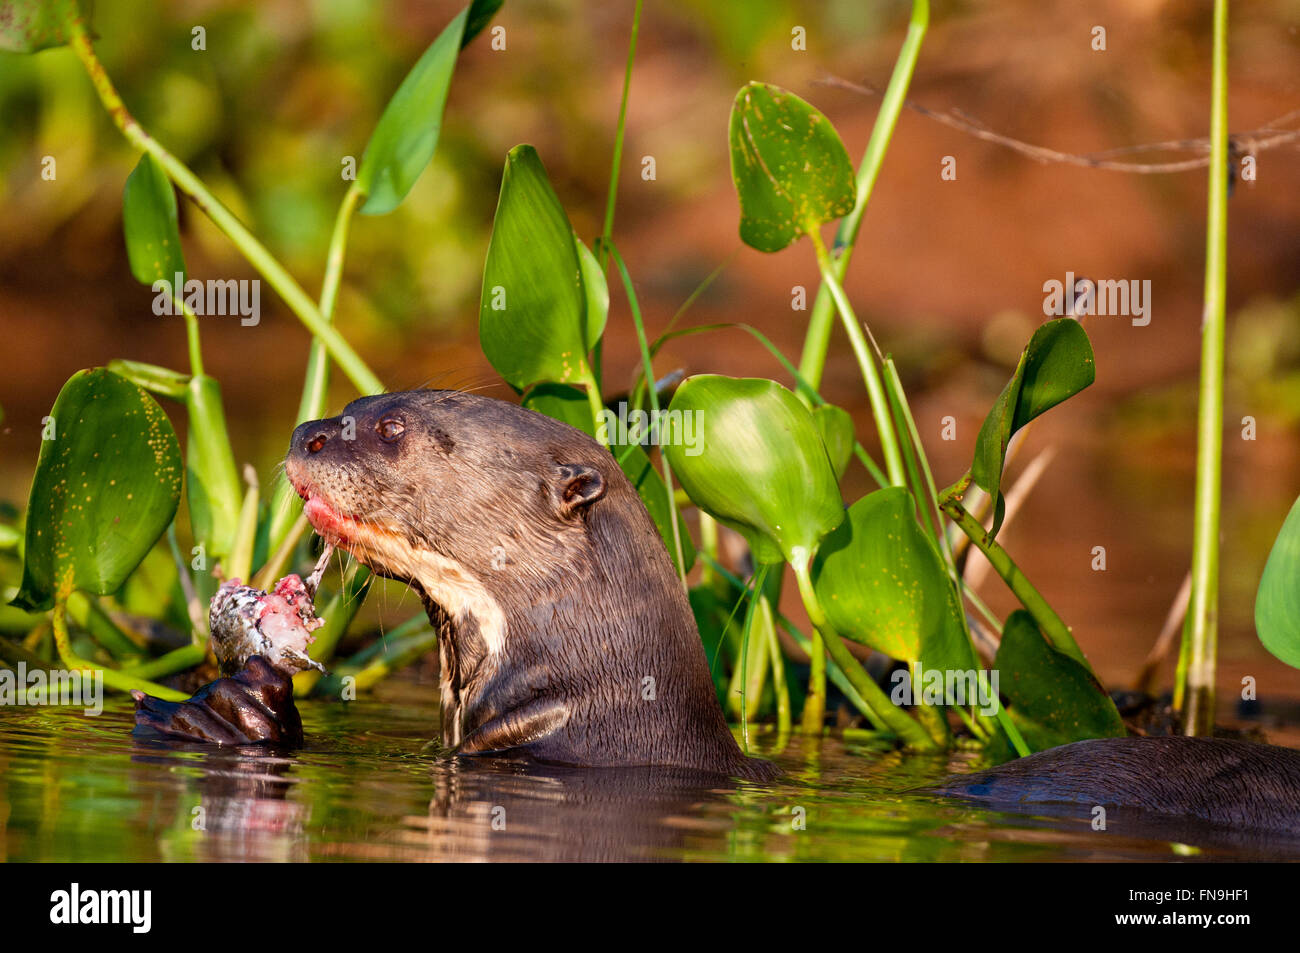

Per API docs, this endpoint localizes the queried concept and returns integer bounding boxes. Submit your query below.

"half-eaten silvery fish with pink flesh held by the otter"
[208,545,334,675]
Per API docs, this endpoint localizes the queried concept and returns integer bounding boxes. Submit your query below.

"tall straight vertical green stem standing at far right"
[1175,0,1231,735]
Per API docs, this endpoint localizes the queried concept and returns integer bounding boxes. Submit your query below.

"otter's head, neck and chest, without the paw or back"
[285,390,776,779]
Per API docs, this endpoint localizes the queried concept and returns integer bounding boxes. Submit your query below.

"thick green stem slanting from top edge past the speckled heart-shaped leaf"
[800,0,930,389]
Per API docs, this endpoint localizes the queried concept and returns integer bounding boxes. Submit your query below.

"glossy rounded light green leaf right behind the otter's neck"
[664,374,844,563]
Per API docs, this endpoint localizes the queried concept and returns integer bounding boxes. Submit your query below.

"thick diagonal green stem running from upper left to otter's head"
[62,3,384,394]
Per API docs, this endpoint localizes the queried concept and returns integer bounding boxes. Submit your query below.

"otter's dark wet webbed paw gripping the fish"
[131,655,303,746]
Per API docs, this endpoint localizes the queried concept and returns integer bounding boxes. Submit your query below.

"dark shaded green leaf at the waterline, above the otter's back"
[993,608,1128,751]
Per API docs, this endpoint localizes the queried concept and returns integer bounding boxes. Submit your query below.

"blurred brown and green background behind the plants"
[0,0,1300,707]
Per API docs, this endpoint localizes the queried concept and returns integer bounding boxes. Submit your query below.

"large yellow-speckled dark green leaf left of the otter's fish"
[13,368,182,611]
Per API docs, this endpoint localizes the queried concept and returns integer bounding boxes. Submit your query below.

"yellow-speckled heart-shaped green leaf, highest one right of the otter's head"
[729,83,857,251]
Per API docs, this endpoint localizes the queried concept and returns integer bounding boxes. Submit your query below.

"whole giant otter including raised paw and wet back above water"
[129,390,1300,831]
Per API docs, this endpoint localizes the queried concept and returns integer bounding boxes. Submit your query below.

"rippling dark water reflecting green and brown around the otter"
[0,681,1296,861]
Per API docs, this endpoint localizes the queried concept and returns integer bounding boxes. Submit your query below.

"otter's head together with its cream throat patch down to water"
[285,390,621,744]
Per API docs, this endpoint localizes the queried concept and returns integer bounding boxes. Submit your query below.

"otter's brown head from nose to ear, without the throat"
[285,390,614,585]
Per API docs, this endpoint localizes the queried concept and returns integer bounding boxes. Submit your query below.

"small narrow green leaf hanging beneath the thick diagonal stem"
[122,152,185,286]
